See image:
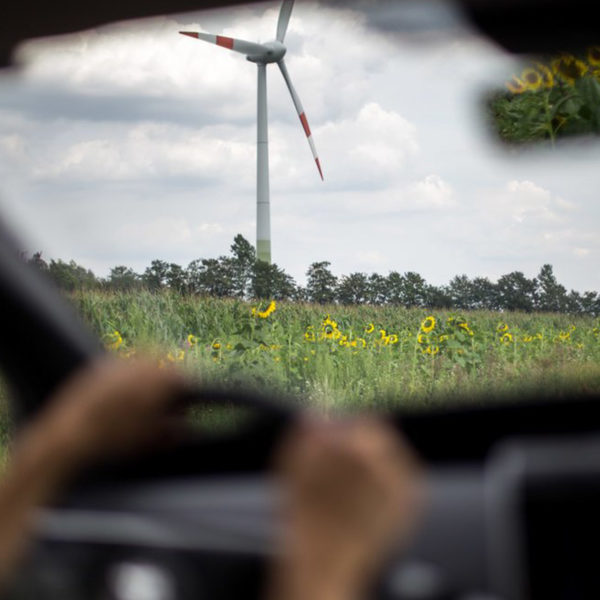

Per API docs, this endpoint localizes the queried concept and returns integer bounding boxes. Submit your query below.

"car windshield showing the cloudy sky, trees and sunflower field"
[0,3,600,408]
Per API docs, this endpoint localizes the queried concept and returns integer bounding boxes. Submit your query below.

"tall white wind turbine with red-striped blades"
[179,0,323,263]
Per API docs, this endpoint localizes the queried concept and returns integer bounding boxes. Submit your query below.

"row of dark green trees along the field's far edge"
[27,234,600,316]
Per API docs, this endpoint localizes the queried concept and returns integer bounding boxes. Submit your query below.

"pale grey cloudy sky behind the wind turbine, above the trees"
[0,3,600,291]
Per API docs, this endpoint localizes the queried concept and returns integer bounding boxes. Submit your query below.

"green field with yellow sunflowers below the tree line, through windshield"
[58,291,600,410]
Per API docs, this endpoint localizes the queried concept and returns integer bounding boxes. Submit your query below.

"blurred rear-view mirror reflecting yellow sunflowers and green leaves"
[489,46,600,144]
